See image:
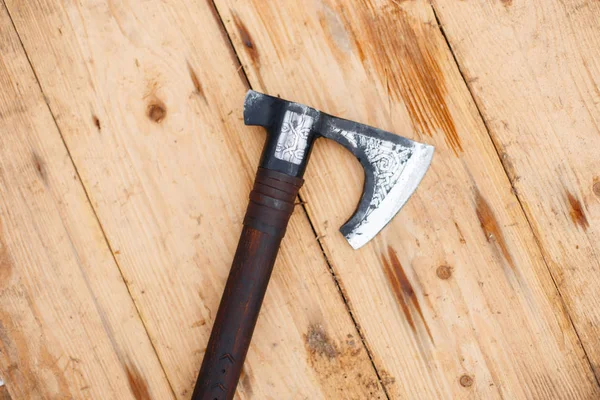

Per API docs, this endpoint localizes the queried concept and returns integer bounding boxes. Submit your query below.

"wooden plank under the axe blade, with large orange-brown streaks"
[216,0,600,399]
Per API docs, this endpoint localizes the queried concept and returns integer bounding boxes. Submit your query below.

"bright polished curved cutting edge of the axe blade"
[340,142,434,249]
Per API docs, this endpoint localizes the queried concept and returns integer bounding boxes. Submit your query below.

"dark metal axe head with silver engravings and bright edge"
[244,90,433,249]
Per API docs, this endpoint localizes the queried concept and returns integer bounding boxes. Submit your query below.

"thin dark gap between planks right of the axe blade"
[429,2,600,387]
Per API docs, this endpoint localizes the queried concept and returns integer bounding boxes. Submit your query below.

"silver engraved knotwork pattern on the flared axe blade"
[339,130,413,229]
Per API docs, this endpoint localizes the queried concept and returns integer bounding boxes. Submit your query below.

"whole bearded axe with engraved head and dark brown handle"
[192,90,433,400]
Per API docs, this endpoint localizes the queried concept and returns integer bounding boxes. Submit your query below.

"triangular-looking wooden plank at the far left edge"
[0,3,173,399]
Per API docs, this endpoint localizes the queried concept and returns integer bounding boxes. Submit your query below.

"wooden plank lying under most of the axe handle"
[7,0,383,399]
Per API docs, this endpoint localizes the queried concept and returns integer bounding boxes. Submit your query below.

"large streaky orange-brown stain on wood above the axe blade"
[348,3,463,156]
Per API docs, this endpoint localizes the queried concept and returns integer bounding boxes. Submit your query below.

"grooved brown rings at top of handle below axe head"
[244,168,304,237]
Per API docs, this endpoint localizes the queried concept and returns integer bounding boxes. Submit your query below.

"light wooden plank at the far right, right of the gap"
[435,0,600,379]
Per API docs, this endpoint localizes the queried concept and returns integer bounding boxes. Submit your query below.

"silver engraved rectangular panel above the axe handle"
[275,110,314,165]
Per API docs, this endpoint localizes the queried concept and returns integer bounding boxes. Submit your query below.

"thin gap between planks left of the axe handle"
[0,0,177,399]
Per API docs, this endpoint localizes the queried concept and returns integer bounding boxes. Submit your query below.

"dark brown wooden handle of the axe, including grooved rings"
[192,168,303,400]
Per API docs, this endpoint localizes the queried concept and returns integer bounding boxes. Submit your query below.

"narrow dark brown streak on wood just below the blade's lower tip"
[381,246,434,343]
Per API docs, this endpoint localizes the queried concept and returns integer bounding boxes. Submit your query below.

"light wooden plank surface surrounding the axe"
[0,0,600,399]
